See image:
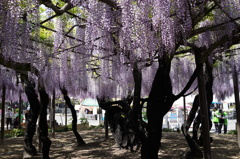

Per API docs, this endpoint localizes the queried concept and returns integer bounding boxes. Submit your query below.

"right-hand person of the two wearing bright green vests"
[217,109,228,134]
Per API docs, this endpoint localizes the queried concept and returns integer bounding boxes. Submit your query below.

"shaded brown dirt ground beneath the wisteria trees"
[0,129,240,159]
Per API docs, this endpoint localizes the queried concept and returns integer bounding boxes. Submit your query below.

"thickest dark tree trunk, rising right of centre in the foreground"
[145,57,175,159]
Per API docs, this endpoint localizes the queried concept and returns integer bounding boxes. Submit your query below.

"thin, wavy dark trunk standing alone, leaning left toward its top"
[61,89,86,146]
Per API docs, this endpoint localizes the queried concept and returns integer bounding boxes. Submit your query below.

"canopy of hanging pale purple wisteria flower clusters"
[0,0,240,102]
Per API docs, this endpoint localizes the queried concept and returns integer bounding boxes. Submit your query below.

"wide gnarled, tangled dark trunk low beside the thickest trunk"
[97,96,143,151]
